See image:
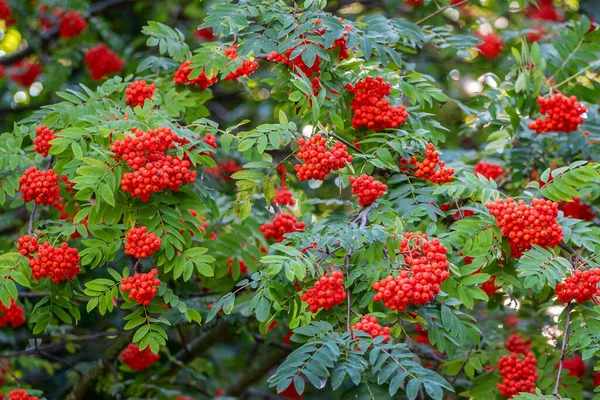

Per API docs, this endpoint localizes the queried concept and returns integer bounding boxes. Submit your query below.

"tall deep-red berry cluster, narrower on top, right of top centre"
[346,76,408,132]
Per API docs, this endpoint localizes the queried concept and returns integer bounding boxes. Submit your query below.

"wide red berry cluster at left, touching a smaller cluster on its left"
[29,242,81,283]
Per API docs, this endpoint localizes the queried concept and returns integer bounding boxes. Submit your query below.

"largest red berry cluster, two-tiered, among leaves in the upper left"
[111,127,196,201]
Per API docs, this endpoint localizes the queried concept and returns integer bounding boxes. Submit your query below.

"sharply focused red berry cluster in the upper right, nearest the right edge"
[527,93,587,135]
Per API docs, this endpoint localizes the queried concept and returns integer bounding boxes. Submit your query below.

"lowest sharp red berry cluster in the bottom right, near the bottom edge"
[498,352,539,398]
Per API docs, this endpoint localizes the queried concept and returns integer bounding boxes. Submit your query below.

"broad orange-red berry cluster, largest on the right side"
[486,197,563,258]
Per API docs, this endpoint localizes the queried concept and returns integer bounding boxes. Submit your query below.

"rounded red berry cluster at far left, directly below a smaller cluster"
[19,167,60,205]
